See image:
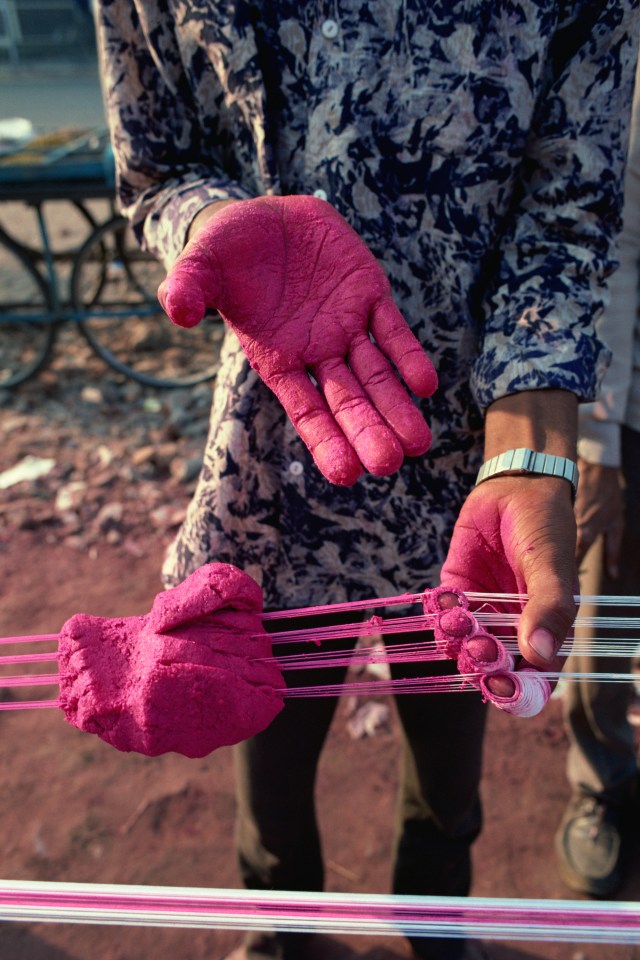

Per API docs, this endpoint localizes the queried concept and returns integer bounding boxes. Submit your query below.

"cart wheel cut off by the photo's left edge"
[0,238,56,388]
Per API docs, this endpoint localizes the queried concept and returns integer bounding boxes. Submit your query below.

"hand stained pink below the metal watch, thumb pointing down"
[442,476,576,696]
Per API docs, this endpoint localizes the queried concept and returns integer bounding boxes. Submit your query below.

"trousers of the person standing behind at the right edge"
[563,427,640,803]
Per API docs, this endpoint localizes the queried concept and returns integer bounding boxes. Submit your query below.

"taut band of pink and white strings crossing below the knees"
[0,880,640,944]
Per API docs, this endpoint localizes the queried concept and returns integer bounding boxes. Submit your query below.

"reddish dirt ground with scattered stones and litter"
[0,202,640,960]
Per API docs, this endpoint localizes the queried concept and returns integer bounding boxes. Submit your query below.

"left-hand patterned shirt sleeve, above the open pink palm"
[97,0,253,267]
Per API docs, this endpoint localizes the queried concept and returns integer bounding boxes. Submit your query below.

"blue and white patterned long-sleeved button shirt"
[99,0,638,606]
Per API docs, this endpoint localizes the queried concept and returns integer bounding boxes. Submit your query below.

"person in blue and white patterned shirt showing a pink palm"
[98,0,638,960]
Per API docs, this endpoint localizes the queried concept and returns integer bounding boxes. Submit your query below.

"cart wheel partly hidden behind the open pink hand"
[71,217,222,387]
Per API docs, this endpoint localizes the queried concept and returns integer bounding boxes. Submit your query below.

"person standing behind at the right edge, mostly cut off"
[555,58,640,897]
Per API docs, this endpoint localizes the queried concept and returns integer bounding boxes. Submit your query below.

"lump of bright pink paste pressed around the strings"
[58,563,285,757]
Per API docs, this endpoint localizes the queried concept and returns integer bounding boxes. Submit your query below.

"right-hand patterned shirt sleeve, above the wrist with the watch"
[472,0,639,408]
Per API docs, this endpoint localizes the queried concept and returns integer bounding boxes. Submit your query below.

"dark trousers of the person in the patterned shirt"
[235,621,486,960]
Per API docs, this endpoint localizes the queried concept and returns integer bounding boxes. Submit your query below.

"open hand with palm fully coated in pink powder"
[158,196,437,486]
